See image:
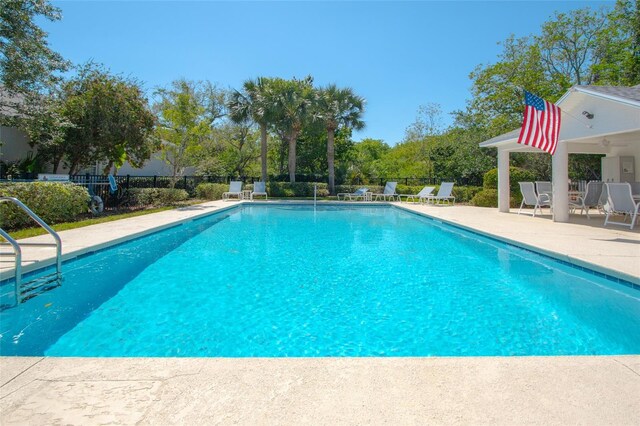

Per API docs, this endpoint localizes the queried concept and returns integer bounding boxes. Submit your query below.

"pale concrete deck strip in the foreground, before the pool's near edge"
[0,356,640,425]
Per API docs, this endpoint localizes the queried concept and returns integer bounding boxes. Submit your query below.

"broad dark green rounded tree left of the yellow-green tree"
[61,63,156,174]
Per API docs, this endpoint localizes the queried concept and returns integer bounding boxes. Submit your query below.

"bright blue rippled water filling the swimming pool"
[0,205,640,357]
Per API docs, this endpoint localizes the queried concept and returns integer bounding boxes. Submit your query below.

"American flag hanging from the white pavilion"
[518,90,561,155]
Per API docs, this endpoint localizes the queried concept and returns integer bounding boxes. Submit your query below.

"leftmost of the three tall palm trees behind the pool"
[229,77,273,182]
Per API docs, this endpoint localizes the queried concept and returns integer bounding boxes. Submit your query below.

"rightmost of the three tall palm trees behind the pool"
[314,84,365,194]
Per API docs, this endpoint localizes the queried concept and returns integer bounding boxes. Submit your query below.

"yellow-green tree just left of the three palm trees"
[153,79,226,185]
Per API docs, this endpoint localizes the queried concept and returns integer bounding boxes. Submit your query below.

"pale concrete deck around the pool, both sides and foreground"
[0,201,640,425]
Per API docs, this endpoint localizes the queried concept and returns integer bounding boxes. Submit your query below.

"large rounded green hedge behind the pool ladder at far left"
[0,182,89,229]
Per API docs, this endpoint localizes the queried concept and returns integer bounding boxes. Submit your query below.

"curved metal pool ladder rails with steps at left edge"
[0,197,62,306]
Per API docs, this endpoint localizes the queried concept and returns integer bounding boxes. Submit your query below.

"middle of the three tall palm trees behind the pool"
[268,76,313,183]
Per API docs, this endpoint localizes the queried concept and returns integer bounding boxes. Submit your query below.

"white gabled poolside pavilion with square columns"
[480,85,640,222]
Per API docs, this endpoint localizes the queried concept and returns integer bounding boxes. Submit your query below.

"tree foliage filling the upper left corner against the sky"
[0,0,68,93]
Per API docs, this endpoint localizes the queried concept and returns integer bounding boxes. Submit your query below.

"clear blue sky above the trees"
[43,1,613,145]
